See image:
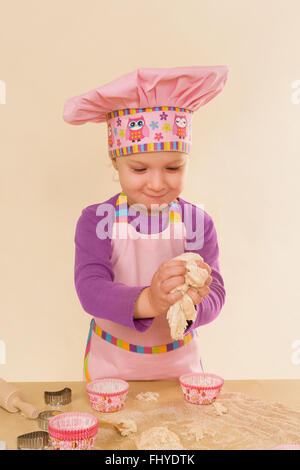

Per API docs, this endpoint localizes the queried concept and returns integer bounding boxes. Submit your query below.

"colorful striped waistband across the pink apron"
[90,319,196,354]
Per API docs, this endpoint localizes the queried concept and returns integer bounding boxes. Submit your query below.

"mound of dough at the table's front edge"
[136,426,184,450]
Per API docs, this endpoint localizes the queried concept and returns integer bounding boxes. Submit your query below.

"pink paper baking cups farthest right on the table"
[179,374,224,405]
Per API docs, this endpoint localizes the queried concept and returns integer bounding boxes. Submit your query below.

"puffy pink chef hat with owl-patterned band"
[63,65,228,159]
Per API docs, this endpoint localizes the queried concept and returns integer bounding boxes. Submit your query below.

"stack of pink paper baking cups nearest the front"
[48,412,98,450]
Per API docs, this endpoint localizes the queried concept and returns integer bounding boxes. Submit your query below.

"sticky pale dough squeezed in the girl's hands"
[167,252,209,340]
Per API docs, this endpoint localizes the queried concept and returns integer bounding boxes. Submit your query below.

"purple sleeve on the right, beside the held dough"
[179,205,226,335]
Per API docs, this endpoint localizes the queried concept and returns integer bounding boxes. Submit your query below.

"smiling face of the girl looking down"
[112,152,189,211]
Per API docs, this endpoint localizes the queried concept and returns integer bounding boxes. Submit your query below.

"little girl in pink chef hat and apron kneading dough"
[63,66,228,381]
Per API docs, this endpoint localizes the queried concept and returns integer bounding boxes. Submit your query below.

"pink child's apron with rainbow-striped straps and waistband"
[84,192,202,382]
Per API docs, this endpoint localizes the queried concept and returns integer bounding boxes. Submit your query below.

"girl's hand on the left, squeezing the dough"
[148,260,187,317]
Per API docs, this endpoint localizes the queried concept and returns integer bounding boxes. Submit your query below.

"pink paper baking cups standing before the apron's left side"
[86,378,129,413]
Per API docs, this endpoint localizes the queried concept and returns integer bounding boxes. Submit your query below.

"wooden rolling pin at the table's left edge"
[0,378,39,419]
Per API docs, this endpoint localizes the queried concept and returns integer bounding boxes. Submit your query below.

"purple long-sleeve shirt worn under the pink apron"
[74,193,226,335]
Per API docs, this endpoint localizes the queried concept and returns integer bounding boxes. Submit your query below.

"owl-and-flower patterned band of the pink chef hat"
[106,106,193,159]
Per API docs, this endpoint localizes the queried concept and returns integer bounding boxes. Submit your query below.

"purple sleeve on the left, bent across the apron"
[74,204,153,332]
